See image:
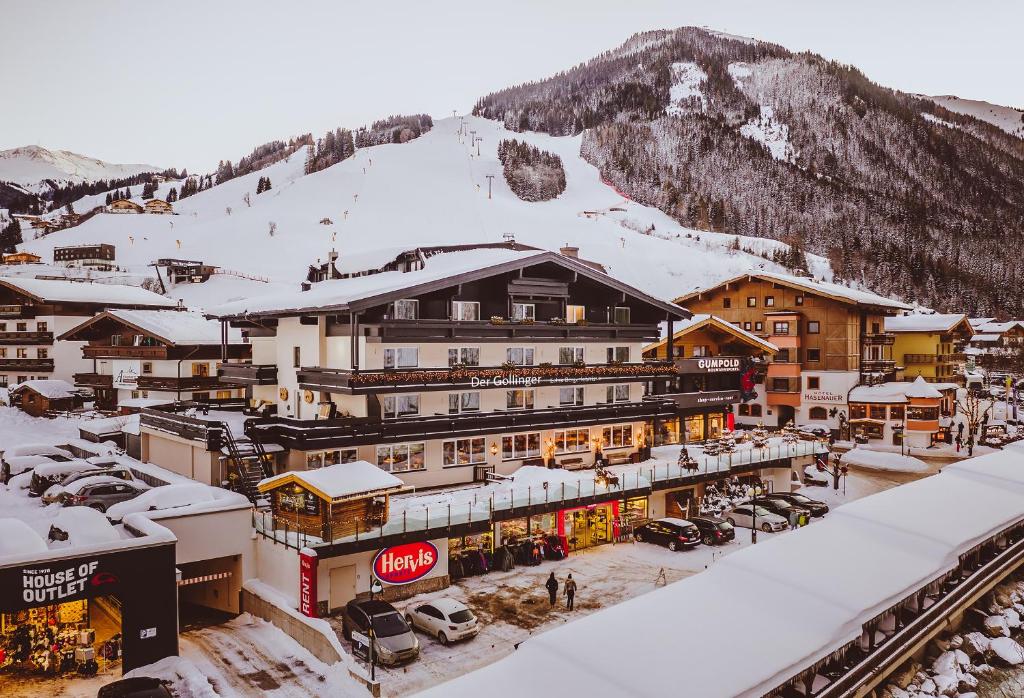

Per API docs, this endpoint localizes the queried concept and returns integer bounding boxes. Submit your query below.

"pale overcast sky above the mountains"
[0,0,1024,171]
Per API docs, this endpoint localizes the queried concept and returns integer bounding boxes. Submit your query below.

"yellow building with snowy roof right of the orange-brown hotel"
[886,313,973,383]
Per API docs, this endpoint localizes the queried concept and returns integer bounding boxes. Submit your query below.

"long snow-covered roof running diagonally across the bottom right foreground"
[422,451,1024,698]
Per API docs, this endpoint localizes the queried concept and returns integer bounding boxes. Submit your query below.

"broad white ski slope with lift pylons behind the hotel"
[14,118,830,304]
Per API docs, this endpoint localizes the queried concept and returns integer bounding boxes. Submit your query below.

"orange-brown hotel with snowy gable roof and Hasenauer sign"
[676,272,910,431]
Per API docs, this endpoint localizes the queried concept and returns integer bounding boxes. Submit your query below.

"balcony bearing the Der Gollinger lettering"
[298,361,676,394]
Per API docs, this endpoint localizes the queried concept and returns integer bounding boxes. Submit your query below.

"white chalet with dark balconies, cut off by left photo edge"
[0,276,174,386]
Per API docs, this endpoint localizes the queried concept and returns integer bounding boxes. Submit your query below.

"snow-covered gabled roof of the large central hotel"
[208,248,688,318]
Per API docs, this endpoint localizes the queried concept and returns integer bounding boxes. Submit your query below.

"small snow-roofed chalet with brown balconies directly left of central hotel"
[58,309,250,407]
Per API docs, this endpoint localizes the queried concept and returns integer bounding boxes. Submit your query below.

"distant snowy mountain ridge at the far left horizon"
[0,145,165,189]
